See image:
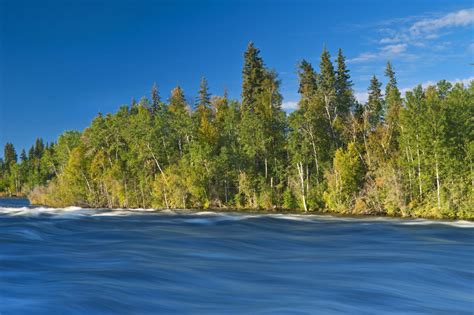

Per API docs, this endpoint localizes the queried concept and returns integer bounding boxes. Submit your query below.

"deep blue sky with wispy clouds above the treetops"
[0,0,474,156]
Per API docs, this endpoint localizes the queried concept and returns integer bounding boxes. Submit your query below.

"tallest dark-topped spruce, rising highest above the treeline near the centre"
[239,43,285,208]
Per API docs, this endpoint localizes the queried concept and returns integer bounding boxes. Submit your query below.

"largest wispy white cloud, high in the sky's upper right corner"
[349,9,474,63]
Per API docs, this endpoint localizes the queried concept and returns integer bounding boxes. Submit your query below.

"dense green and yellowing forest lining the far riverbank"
[0,43,474,219]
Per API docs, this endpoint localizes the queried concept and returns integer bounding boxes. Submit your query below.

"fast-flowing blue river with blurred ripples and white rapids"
[0,199,474,314]
